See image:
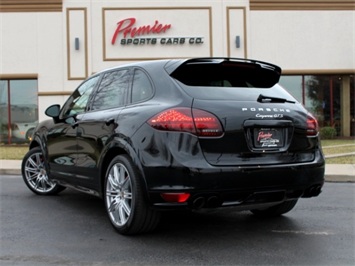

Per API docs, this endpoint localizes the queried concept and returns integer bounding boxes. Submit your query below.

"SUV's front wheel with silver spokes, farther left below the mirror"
[21,147,65,195]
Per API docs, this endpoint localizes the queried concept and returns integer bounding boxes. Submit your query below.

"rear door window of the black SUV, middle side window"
[91,69,129,110]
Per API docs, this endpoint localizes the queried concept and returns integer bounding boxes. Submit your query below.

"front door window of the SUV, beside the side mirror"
[62,76,99,116]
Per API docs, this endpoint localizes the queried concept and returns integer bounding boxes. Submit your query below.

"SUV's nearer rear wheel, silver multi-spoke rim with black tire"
[104,155,160,235]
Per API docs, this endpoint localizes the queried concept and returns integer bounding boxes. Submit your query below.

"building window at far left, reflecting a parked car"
[0,79,38,144]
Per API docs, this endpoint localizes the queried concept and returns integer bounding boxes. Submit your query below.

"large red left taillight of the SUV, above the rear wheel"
[148,107,223,137]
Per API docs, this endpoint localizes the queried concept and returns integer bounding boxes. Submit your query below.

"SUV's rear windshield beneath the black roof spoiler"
[170,60,296,101]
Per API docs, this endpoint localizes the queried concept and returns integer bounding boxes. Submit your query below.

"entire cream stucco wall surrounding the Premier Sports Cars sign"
[0,0,355,120]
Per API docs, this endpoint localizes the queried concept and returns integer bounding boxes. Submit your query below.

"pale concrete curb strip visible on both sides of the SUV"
[0,160,355,182]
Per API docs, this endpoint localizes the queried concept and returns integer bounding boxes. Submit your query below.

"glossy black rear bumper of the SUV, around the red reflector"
[143,157,325,210]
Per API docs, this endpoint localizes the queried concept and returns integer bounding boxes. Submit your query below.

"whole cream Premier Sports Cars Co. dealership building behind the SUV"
[0,0,355,143]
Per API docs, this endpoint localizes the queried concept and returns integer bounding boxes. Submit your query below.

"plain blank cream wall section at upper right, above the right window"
[249,10,355,70]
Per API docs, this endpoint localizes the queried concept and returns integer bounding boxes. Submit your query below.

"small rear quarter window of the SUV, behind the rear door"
[131,69,153,103]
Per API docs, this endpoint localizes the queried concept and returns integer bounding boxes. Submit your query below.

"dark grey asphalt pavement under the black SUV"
[0,175,355,265]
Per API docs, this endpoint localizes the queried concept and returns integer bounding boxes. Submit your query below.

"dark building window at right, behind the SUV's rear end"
[280,75,354,136]
